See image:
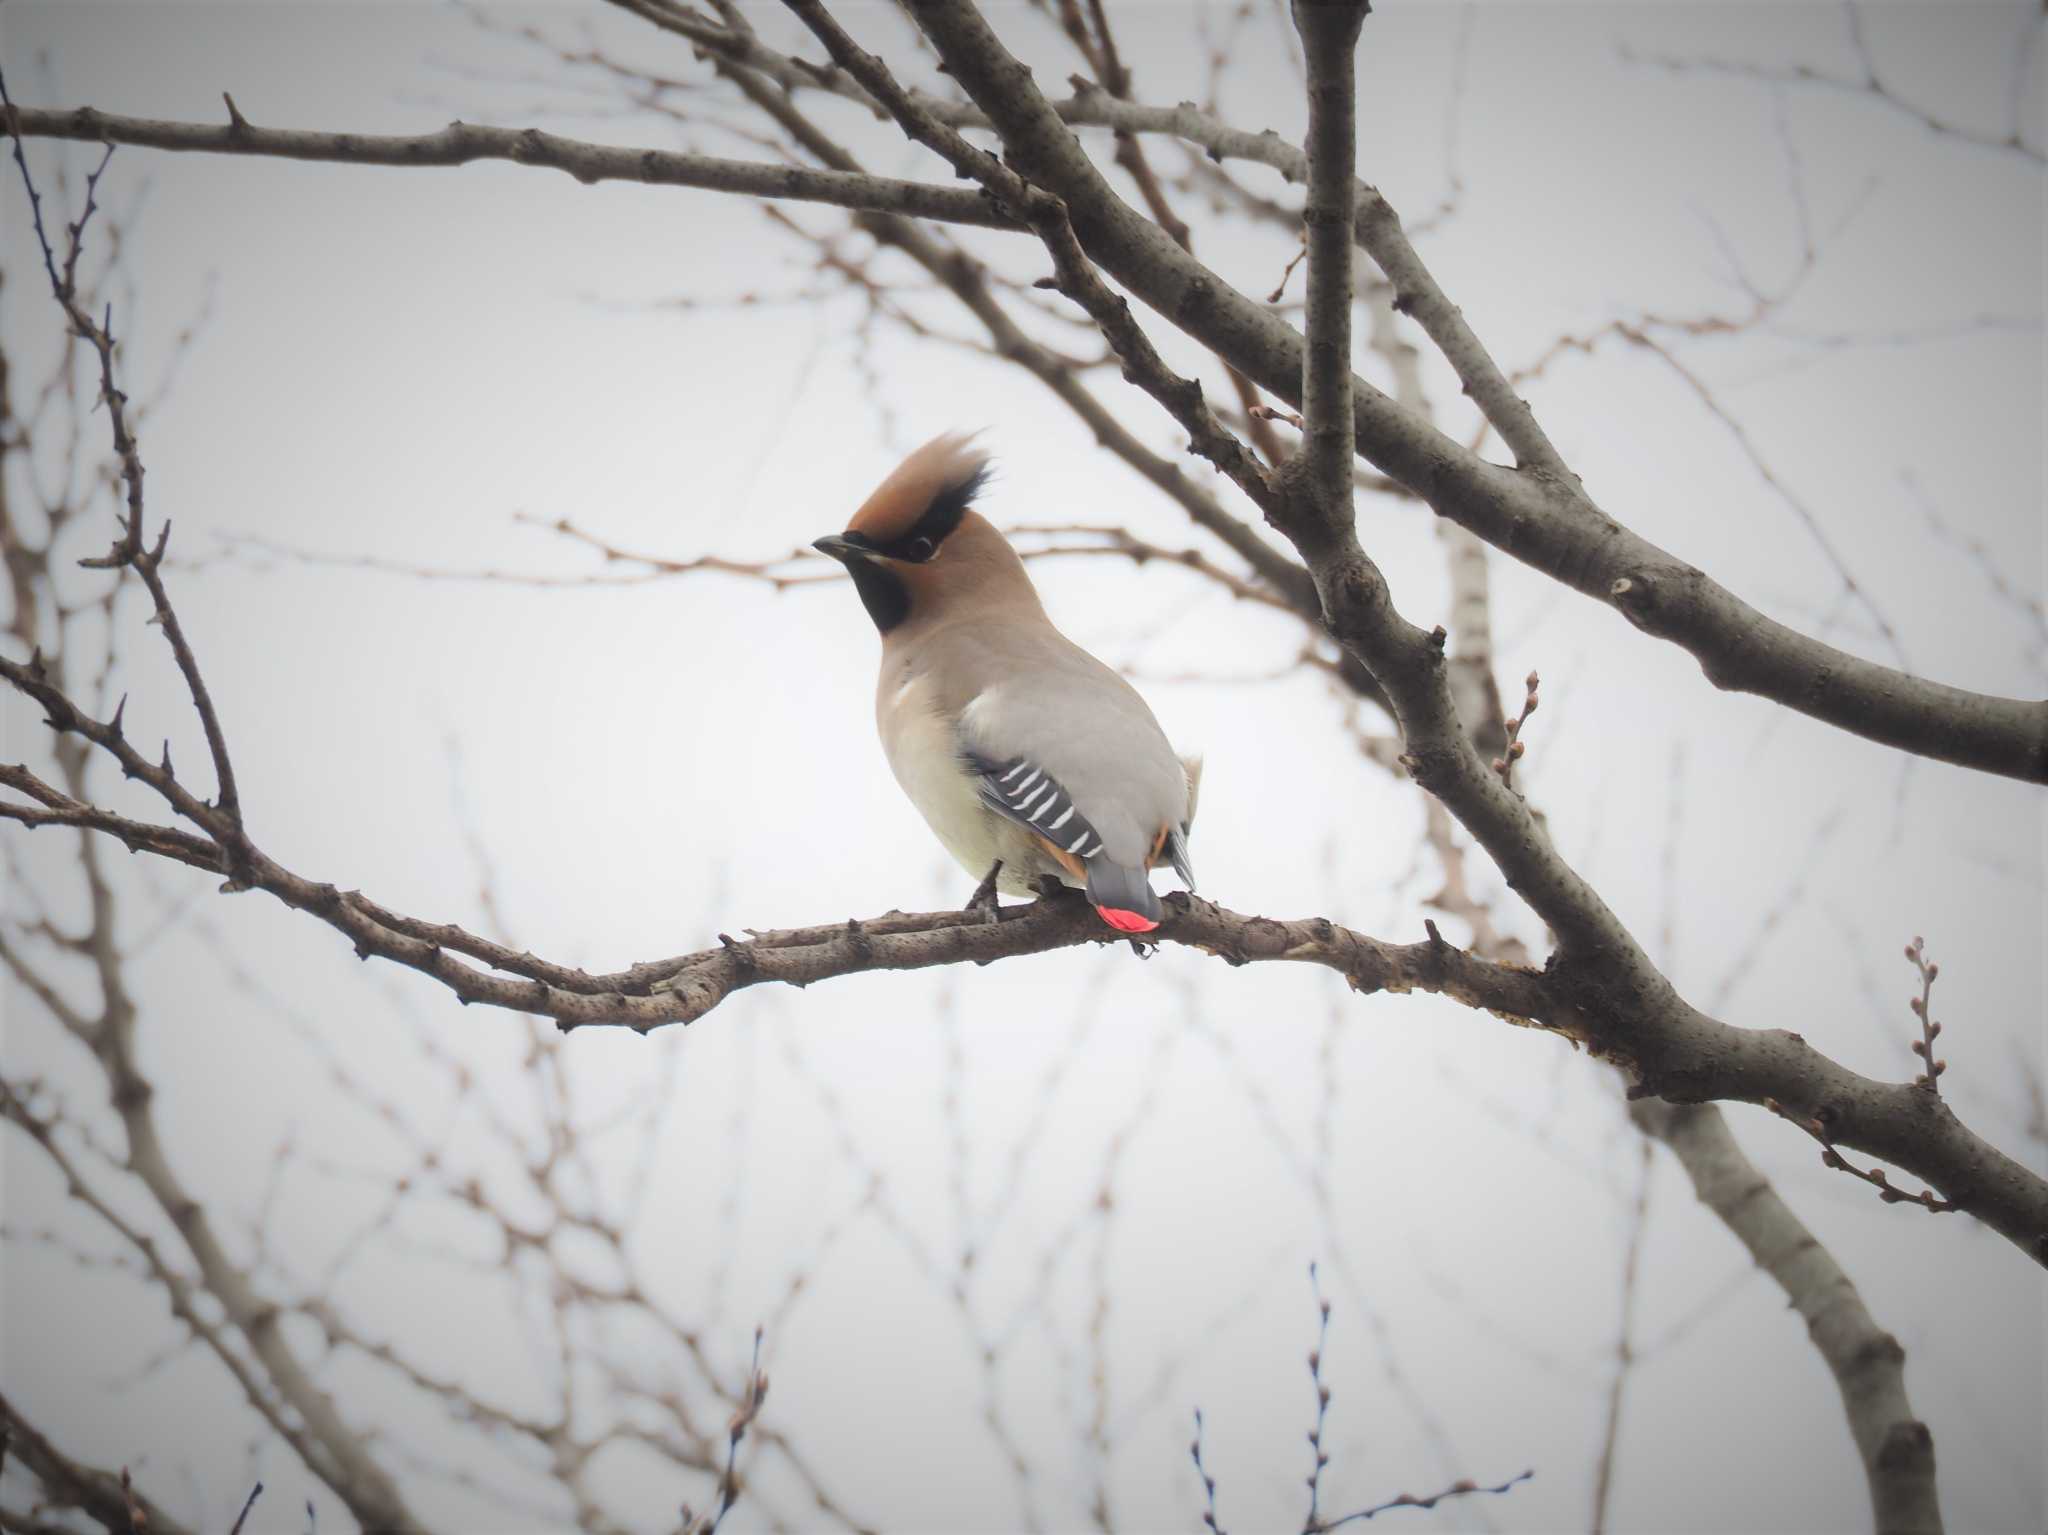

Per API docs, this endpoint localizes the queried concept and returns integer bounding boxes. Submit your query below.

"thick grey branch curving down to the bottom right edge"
[1632,1103,1942,1535]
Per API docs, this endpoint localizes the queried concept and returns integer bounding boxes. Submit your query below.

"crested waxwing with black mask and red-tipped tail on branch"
[811,432,1202,933]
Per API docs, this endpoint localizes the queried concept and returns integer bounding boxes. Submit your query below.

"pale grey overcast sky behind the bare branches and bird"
[0,0,2048,1531]
